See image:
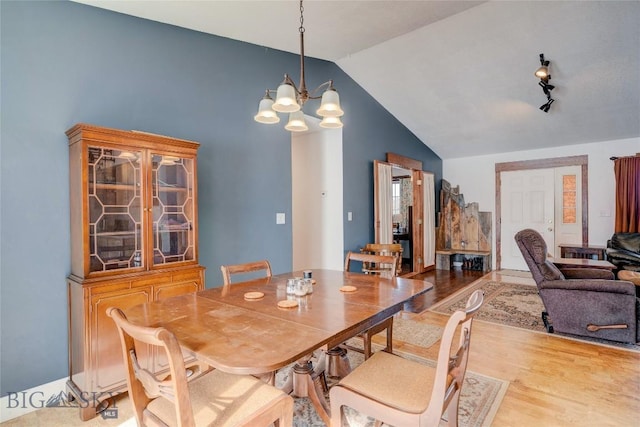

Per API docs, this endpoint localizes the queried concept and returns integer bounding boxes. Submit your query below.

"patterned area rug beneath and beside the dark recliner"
[429,281,640,351]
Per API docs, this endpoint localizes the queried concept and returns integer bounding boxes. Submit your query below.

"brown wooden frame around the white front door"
[495,155,589,270]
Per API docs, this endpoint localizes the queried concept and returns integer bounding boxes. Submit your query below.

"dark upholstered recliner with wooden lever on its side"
[515,229,640,343]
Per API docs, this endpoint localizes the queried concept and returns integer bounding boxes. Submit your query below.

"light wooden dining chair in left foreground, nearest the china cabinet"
[107,307,293,427]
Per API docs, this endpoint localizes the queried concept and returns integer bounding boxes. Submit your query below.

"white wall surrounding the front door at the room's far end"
[442,138,640,269]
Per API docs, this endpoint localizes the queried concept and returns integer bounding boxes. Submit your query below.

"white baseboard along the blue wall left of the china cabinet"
[0,378,68,423]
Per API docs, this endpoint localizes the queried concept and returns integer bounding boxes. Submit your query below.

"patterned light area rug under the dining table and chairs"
[276,350,509,427]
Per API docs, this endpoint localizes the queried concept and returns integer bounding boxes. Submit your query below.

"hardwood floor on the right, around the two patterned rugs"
[394,272,640,427]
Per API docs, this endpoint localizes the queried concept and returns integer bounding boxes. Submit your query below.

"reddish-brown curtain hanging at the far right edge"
[613,155,640,233]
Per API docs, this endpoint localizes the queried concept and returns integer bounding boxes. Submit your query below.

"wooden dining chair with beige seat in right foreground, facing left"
[330,290,484,427]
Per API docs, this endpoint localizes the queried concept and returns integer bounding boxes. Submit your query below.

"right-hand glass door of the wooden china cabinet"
[151,153,196,265]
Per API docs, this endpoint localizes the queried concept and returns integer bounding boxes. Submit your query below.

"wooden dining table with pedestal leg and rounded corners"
[126,270,433,425]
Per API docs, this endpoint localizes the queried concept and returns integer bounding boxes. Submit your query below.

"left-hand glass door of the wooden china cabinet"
[88,146,143,272]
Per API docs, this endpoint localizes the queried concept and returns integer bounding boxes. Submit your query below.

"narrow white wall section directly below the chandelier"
[291,120,344,270]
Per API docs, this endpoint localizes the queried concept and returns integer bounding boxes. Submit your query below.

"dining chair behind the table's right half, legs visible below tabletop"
[344,252,398,360]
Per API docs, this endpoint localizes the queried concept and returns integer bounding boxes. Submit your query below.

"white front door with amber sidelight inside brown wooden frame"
[496,156,589,270]
